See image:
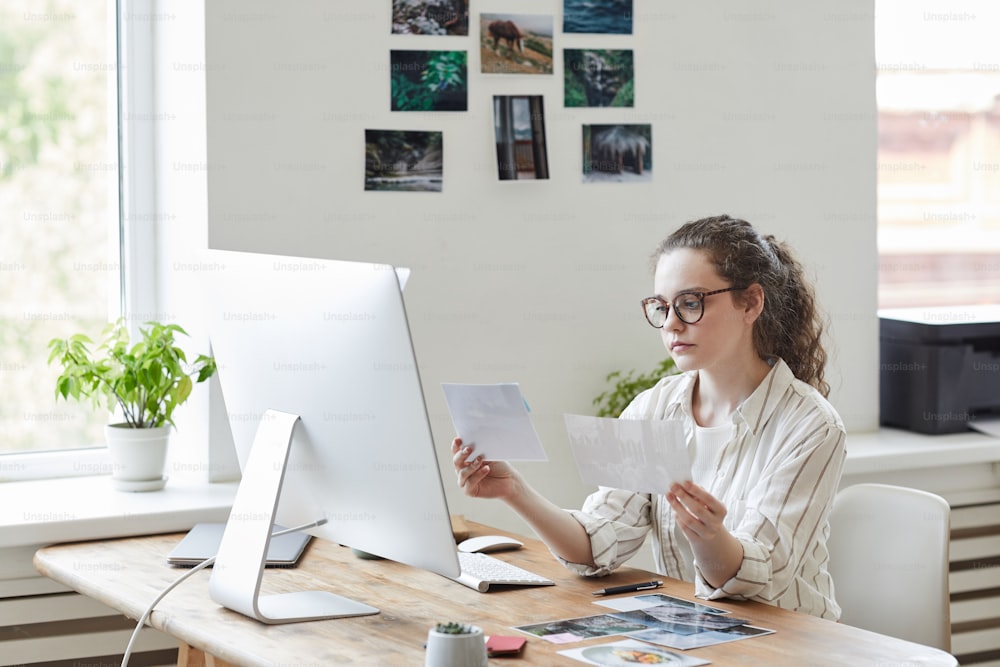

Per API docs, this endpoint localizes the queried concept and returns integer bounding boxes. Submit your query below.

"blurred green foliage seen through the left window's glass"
[0,0,114,453]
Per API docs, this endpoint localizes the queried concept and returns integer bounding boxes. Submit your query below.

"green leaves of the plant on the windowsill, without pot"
[49,320,216,428]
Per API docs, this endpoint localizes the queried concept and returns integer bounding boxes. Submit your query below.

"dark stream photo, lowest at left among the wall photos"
[365,130,444,192]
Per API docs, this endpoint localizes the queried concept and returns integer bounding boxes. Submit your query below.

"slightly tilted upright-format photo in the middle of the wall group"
[493,95,549,181]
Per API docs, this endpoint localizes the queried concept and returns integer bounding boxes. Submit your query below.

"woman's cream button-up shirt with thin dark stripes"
[563,359,846,619]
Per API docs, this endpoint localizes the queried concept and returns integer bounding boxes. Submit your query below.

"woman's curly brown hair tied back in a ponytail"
[651,215,830,396]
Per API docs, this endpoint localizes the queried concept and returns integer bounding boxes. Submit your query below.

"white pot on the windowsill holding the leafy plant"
[104,424,171,491]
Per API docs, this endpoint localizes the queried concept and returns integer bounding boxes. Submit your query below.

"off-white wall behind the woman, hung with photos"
[195,0,878,529]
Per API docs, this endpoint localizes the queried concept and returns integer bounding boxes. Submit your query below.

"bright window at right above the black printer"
[875,0,1000,308]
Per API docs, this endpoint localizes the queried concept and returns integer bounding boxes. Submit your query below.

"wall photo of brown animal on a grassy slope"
[479,14,554,74]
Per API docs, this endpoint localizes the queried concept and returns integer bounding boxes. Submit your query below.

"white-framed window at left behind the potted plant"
[0,0,153,480]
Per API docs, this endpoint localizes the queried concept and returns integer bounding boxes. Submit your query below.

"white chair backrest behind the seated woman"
[828,484,951,651]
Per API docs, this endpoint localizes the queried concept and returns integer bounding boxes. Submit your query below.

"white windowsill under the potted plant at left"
[0,475,239,548]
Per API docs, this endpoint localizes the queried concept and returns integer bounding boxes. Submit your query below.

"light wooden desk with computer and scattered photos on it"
[35,523,957,667]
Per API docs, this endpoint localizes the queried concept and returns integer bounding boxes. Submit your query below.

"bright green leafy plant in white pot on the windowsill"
[49,320,215,491]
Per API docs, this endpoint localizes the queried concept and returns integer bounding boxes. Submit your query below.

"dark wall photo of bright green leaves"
[389,50,469,111]
